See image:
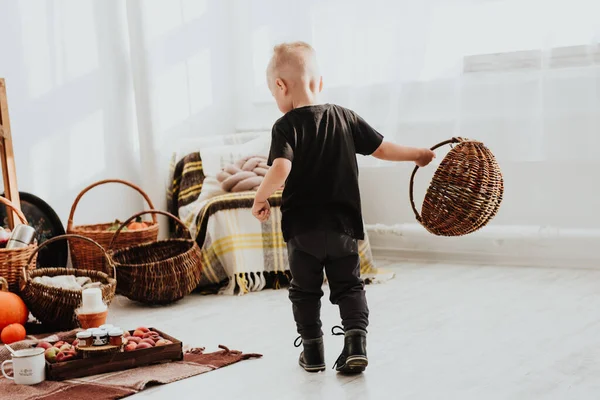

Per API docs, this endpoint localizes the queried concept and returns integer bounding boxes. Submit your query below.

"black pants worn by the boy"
[287,231,369,339]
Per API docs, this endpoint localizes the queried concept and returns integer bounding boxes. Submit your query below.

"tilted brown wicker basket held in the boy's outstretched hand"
[410,138,504,236]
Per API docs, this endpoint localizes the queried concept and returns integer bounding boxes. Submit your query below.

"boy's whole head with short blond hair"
[267,42,323,113]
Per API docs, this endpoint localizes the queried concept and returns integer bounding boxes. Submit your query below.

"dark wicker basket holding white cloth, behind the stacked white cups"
[20,235,117,330]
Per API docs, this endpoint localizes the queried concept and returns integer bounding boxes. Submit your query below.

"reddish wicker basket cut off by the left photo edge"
[0,196,37,293]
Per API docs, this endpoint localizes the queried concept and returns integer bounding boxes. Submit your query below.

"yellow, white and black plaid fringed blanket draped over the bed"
[169,153,394,295]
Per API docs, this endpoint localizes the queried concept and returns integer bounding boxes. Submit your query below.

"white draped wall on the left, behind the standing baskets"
[0,0,235,231]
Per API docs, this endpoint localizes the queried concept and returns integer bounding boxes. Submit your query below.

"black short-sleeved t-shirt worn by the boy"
[269,104,383,241]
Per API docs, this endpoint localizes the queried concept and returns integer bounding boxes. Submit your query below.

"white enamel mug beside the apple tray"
[0,347,46,385]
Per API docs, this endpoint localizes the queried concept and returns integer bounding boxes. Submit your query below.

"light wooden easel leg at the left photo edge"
[0,78,21,229]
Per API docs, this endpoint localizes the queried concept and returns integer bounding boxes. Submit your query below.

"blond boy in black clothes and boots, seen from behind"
[252,42,435,373]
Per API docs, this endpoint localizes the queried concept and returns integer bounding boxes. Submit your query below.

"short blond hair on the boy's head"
[267,42,320,85]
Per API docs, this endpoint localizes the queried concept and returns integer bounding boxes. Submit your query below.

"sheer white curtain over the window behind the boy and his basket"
[236,0,600,233]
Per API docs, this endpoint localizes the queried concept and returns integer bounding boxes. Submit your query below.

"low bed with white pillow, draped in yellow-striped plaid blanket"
[167,133,394,295]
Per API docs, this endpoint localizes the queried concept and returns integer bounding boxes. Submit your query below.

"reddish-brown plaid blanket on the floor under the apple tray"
[0,331,262,400]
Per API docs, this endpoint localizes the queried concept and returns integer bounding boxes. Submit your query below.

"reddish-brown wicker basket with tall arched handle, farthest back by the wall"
[67,179,158,271]
